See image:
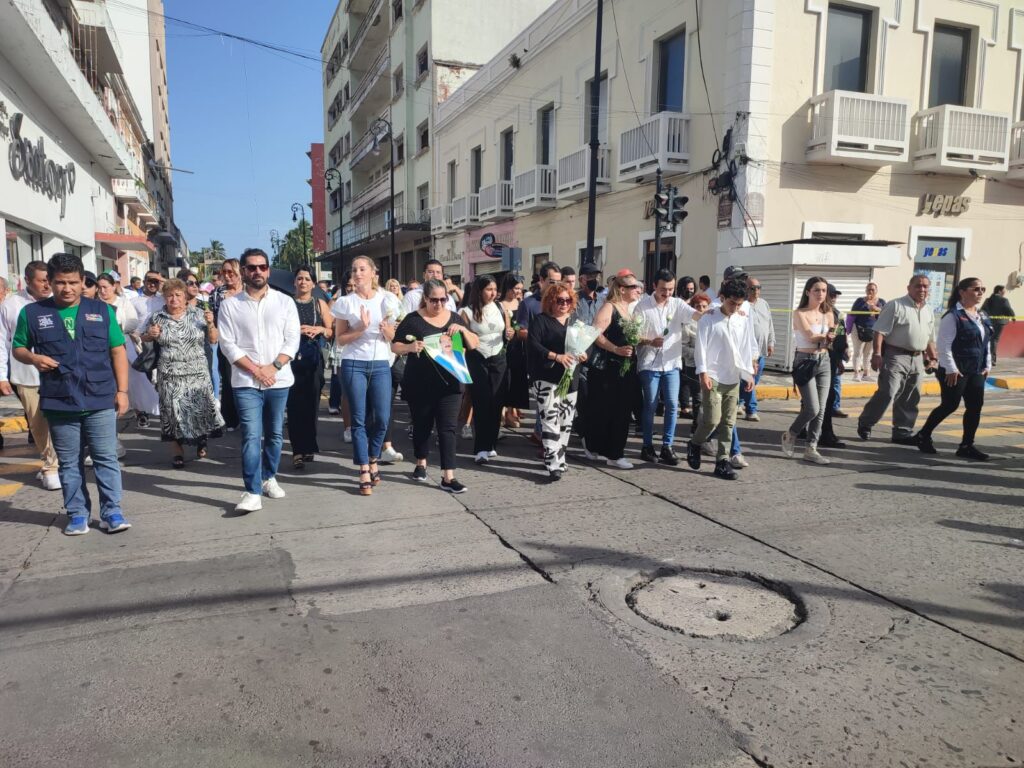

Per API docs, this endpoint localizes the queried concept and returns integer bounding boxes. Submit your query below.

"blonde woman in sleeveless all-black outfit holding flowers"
[584,270,644,469]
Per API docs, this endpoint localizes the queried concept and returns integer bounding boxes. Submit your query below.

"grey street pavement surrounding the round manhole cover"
[0,392,1024,768]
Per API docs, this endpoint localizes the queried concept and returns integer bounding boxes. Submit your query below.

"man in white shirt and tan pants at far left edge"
[0,261,60,490]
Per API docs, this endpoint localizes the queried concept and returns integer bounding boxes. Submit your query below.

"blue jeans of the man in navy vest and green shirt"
[50,409,121,517]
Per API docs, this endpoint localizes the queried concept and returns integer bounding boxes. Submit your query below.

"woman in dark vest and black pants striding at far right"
[914,278,994,462]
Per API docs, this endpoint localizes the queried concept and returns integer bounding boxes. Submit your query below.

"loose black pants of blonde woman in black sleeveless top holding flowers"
[584,364,640,459]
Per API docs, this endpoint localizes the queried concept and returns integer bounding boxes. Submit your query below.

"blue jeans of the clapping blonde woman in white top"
[341,359,391,467]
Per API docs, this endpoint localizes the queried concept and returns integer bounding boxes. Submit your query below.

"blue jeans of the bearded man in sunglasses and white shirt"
[234,387,289,496]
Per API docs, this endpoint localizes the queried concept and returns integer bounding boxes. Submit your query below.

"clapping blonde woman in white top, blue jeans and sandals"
[331,256,401,496]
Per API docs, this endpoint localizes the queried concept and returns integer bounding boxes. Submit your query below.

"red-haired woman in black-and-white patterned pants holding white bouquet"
[526,283,587,480]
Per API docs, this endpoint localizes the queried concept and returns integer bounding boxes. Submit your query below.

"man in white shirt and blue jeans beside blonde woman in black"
[634,269,696,467]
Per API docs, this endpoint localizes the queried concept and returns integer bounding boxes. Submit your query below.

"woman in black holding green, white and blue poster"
[391,280,479,494]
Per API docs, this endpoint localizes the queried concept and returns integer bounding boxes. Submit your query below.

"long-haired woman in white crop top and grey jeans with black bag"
[782,278,836,464]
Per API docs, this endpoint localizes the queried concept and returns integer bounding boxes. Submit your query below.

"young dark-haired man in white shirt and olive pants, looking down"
[686,278,758,480]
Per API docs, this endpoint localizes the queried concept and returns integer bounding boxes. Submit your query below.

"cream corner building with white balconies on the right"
[431,0,1024,364]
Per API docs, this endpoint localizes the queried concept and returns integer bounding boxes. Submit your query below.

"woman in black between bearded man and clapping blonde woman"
[287,265,334,469]
